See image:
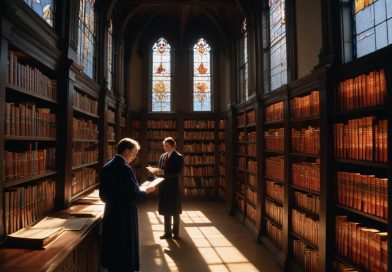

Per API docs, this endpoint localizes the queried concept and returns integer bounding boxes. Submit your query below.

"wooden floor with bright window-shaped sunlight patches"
[138,200,282,272]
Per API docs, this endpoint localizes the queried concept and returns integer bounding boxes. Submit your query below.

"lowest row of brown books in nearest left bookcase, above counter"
[4,179,56,235]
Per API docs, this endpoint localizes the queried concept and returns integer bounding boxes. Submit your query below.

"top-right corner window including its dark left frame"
[341,0,392,62]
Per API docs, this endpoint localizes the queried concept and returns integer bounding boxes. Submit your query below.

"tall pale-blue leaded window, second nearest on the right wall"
[269,0,287,90]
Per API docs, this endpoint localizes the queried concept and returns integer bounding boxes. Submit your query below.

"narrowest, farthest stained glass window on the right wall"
[239,18,248,101]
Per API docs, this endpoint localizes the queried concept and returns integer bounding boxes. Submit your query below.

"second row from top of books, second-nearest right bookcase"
[291,127,320,155]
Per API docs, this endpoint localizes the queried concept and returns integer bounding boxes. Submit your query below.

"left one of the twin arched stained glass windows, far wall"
[151,38,172,112]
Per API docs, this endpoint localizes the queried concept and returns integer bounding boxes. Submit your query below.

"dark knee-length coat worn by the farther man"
[158,150,184,215]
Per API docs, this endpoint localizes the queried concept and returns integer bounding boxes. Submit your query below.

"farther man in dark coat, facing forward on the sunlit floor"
[154,137,184,239]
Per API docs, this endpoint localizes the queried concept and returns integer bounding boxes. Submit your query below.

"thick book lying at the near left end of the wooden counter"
[7,227,64,248]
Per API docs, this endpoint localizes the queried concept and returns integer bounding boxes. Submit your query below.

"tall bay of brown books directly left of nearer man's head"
[71,87,99,201]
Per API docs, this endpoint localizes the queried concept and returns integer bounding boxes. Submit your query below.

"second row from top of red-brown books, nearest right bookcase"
[334,116,388,162]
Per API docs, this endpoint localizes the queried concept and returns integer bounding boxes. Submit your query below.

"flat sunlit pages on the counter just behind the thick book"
[31,217,88,230]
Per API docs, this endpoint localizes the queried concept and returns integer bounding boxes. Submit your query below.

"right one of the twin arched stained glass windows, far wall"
[193,38,211,111]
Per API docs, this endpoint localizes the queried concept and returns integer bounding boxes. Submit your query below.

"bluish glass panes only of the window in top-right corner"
[352,0,392,58]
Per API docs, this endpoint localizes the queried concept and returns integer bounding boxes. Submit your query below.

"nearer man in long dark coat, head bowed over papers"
[99,138,154,272]
